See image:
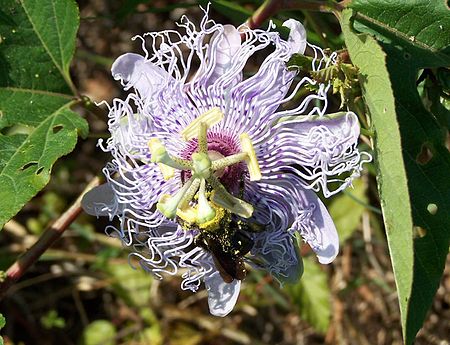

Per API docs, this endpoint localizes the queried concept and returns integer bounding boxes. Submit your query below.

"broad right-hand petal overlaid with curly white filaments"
[254,112,370,197]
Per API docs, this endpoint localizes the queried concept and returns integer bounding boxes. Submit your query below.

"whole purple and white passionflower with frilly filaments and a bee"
[83,6,370,316]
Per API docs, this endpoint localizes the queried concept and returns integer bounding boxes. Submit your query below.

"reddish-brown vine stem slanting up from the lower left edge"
[0,177,100,300]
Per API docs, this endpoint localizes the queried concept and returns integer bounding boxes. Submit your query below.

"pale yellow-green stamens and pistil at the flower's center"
[149,108,261,228]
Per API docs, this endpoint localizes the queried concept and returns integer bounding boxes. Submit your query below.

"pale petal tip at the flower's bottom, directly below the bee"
[205,271,241,317]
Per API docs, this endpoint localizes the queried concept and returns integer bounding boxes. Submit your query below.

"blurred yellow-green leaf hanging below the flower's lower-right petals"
[285,258,331,333]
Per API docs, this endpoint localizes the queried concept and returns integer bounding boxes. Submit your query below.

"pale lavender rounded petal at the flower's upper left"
[111,53,171,98]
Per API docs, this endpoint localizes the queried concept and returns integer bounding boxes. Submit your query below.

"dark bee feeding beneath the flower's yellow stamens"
[196,221,259,283]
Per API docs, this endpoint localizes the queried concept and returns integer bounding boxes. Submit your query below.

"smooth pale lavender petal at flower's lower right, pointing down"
[303,189,339,264]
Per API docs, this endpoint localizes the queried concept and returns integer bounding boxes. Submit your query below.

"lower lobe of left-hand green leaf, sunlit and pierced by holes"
[0,103,88,226]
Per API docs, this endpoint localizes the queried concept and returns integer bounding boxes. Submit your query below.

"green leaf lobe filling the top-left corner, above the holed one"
[0,0,79,93]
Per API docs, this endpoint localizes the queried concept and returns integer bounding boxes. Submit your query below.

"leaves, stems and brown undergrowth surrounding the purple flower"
[0,0,450,345]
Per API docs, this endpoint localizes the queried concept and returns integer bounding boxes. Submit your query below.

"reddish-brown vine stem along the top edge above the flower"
[246,0,349,29]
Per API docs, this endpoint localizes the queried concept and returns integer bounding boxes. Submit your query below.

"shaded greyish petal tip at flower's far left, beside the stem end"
[81,183,119,217]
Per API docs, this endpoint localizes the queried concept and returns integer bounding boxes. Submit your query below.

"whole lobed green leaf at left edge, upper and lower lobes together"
[0,0,88,228]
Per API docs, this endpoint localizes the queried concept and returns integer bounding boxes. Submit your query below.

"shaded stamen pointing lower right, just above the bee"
[208,175,253,218]
